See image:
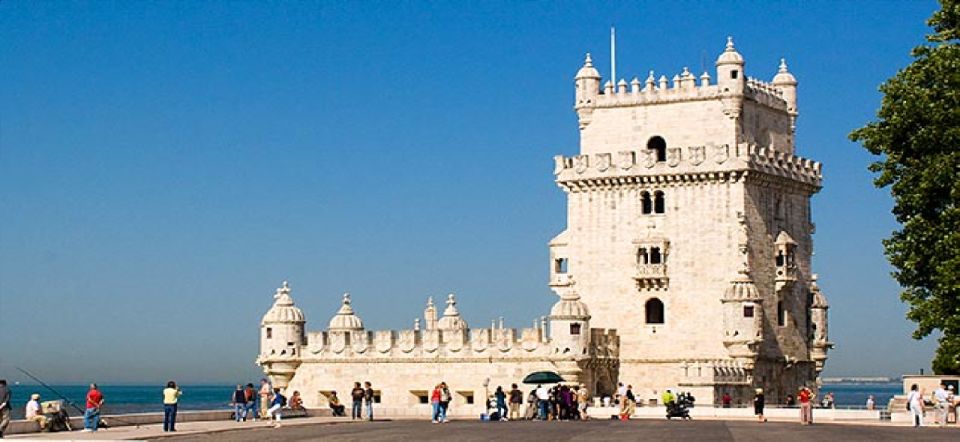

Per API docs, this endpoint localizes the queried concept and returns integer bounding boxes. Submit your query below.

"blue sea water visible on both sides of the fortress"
[10,382,903,419]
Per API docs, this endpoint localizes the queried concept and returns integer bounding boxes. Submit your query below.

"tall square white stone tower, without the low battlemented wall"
[550,38,831,401]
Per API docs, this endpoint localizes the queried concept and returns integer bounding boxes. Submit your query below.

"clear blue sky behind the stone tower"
[0,1,937,383]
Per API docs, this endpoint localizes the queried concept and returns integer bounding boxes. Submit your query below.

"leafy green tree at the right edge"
[850,0,960,374]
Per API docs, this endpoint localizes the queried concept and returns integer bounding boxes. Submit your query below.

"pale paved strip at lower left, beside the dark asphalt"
[6,416,350,440]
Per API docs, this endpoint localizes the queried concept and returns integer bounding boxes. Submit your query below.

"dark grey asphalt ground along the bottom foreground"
[162,420,960,442]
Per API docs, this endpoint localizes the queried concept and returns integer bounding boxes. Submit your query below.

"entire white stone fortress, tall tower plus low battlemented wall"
[257,40,832,406]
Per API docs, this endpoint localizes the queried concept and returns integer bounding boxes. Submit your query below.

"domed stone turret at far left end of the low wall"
[257,281,306,388]
